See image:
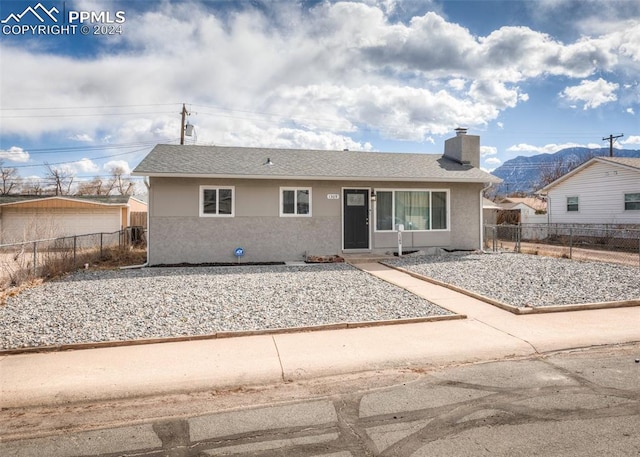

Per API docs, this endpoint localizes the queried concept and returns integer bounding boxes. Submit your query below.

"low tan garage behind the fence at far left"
[0,195,147,244]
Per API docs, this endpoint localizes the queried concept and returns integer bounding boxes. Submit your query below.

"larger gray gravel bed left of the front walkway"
[0,264,451,349]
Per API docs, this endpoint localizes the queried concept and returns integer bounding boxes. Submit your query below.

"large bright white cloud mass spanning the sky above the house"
[0,0,640,153]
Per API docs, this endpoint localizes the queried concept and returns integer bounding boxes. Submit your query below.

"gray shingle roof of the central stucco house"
[133,144,501,183]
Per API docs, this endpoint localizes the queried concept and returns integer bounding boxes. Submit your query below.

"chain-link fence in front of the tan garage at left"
[0,227,146,285]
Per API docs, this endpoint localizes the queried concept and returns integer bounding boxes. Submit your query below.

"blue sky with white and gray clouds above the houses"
[0,0,640,189]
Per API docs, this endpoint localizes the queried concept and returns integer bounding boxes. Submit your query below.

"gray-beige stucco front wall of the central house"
[149,178,482,265]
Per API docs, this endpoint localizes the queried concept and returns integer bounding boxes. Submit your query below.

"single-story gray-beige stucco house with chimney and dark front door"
[133,129,500,265]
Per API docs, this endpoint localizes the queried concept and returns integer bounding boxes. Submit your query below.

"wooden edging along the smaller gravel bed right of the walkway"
[380,262,640,316]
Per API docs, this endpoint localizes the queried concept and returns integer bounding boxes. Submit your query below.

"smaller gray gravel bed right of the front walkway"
[385,253,640,307]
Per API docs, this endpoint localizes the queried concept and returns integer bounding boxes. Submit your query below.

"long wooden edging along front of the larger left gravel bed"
[0,314,467,357]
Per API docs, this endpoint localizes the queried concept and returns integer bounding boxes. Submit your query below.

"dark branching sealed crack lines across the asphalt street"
[48,358,640,457]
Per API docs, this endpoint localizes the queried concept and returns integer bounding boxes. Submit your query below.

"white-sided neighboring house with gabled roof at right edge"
[537,157,640,224]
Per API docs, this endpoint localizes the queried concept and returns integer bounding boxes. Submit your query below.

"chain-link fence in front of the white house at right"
[484,224,640,267]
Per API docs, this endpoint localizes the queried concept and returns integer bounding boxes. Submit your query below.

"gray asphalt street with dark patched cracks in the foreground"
[0,343,640,457]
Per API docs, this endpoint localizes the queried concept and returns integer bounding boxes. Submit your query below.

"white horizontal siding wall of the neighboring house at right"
[548,162,640,224]
